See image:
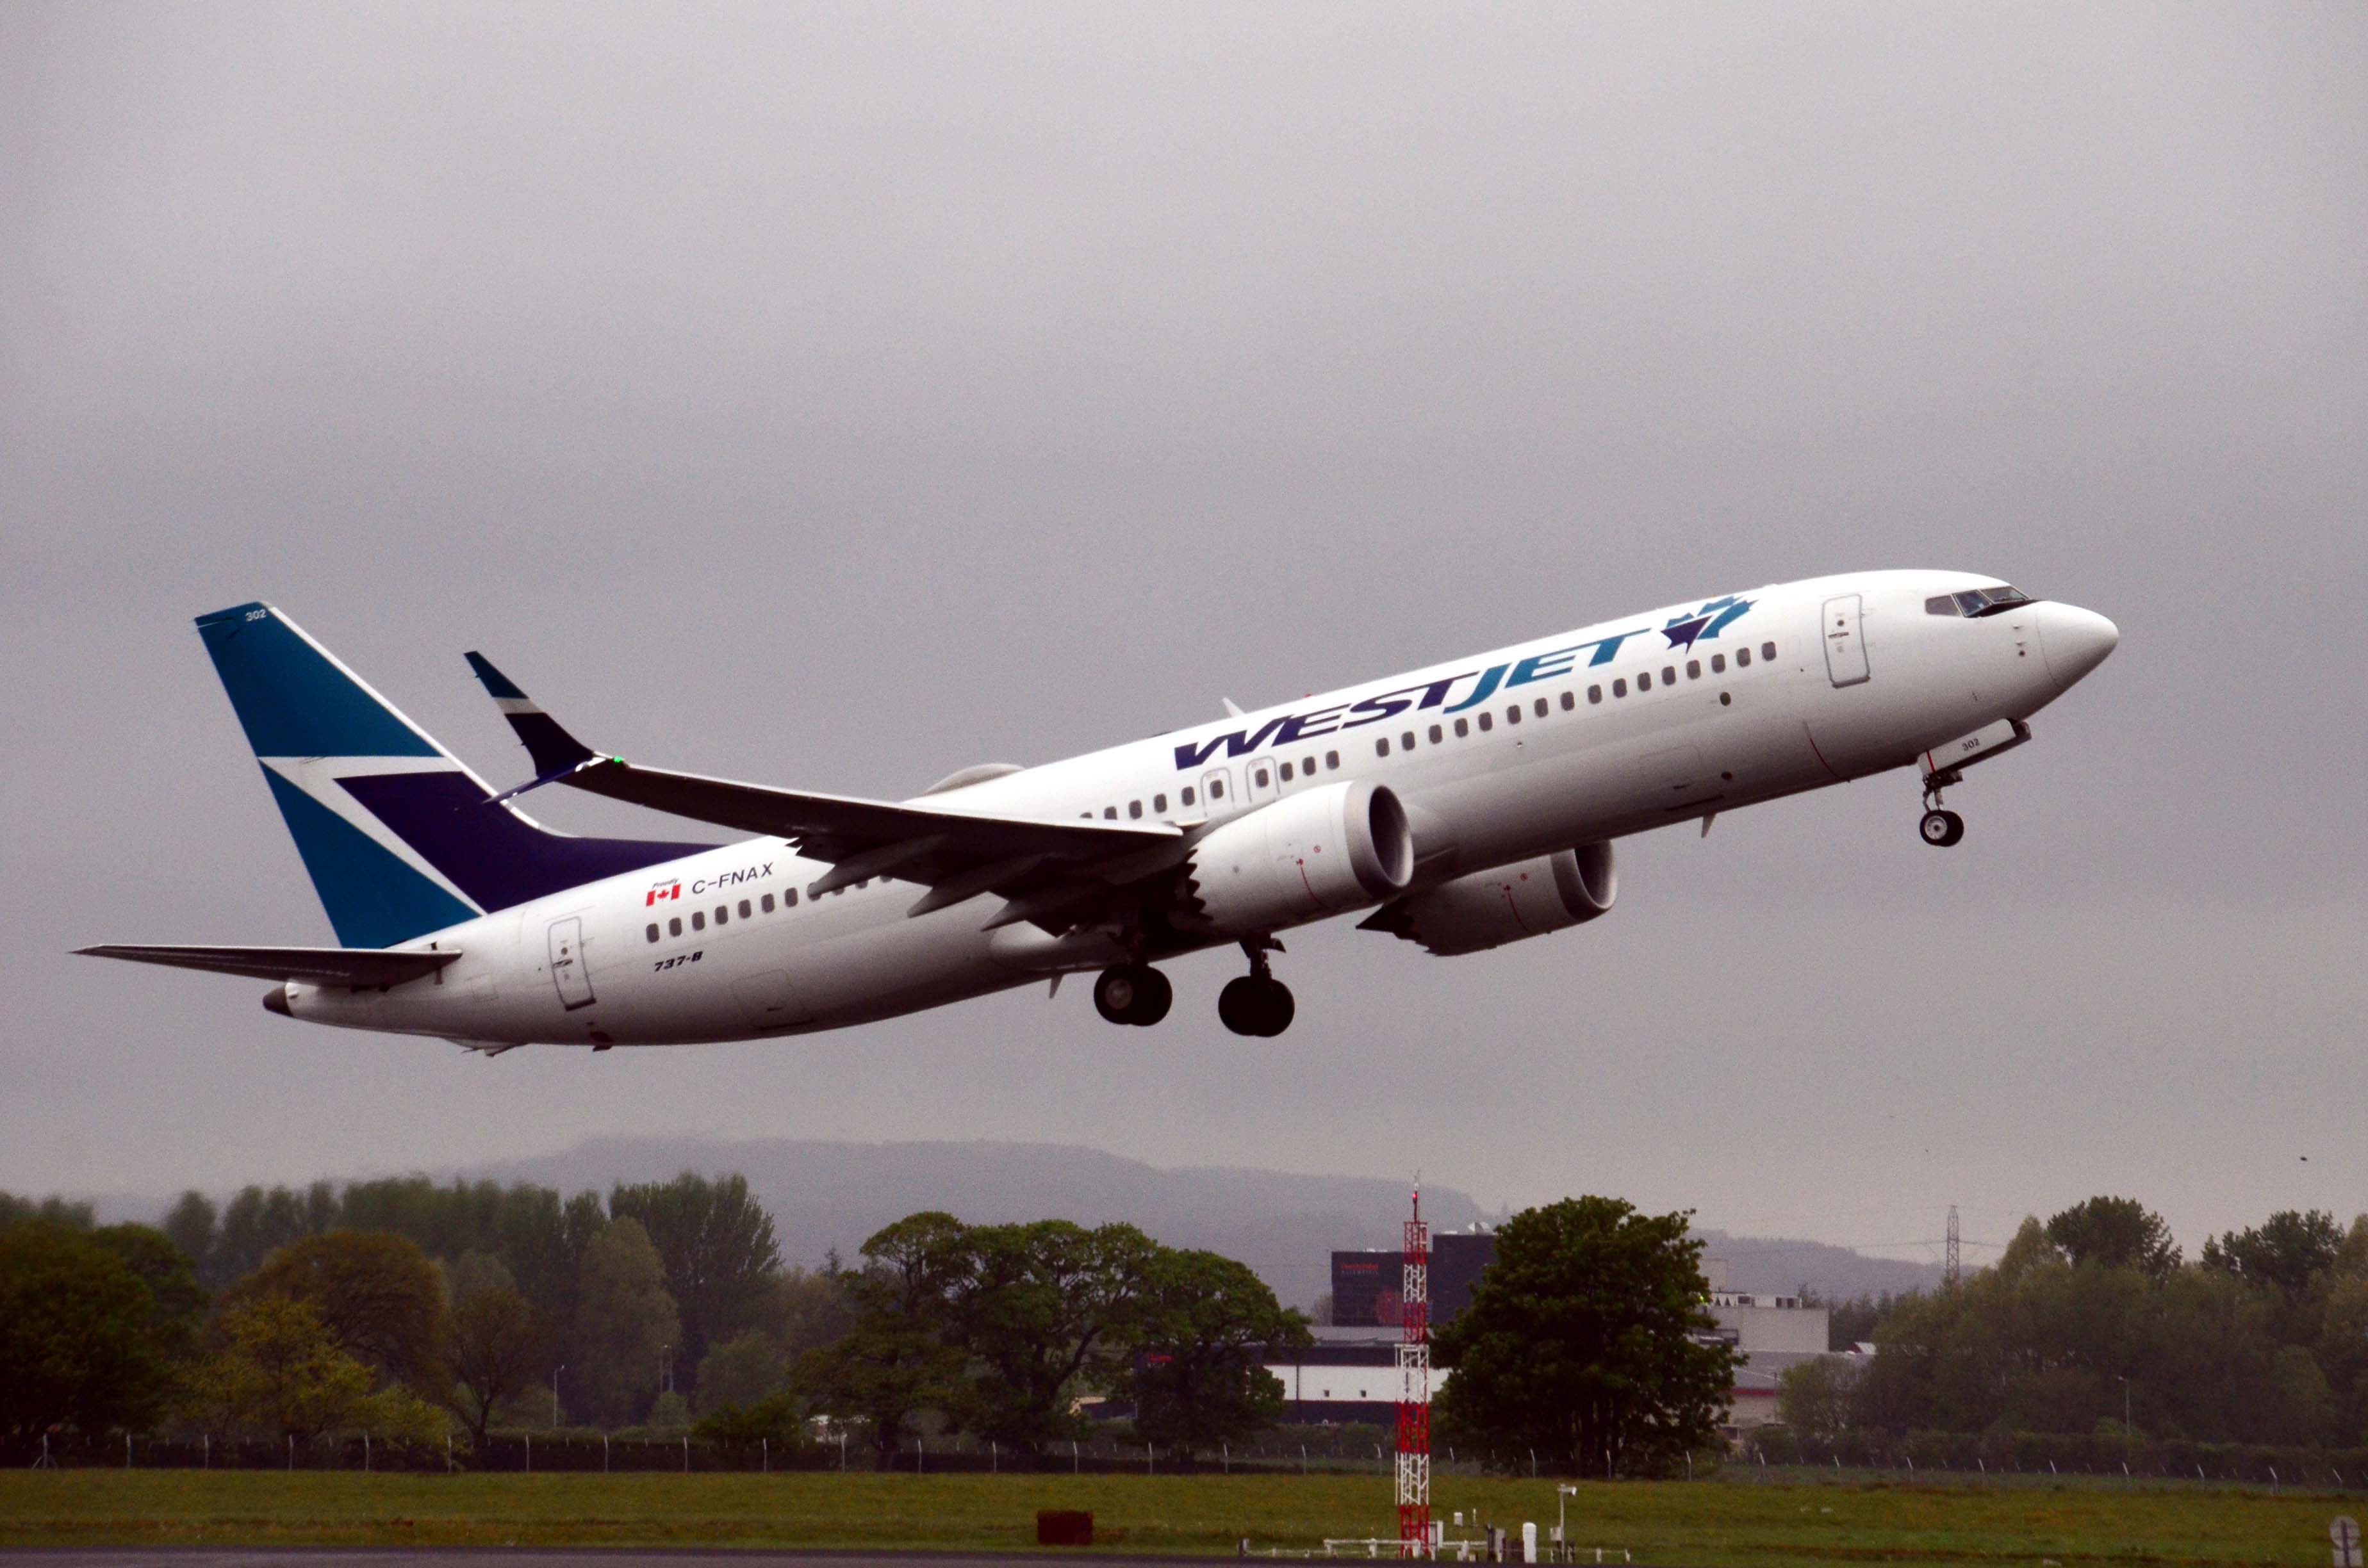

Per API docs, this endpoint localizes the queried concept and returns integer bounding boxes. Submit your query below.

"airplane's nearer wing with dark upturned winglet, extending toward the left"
[469,654,1184,926]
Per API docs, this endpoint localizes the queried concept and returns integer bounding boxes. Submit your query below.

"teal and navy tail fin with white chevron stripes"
[197,604,705,947]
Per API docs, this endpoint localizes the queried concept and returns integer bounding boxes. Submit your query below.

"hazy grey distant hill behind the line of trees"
[447,1137,1939,1307]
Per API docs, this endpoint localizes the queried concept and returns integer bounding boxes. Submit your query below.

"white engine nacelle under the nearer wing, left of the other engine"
[1184,780,1414,936]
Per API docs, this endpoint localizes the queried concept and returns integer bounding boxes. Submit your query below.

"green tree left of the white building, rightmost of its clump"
[1110,1248,1314,1452]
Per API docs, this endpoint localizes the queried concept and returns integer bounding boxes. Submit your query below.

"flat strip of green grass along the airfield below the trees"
[0,1471,2358,1568]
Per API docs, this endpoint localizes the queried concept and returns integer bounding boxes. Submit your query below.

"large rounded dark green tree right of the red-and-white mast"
[1435,1196,1738,1476]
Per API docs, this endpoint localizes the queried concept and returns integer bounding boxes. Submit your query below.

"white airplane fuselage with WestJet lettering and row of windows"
[286,571,2103,1045]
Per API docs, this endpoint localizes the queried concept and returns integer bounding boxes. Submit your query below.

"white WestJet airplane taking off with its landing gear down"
[78,571,2119,1054]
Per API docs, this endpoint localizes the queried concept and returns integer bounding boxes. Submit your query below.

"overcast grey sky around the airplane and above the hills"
[0,3,2368,1255]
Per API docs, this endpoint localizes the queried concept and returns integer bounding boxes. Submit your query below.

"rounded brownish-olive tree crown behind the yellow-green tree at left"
[230,1232,445,1392]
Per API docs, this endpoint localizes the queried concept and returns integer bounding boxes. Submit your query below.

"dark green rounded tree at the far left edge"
[0,1220,170,1438]
